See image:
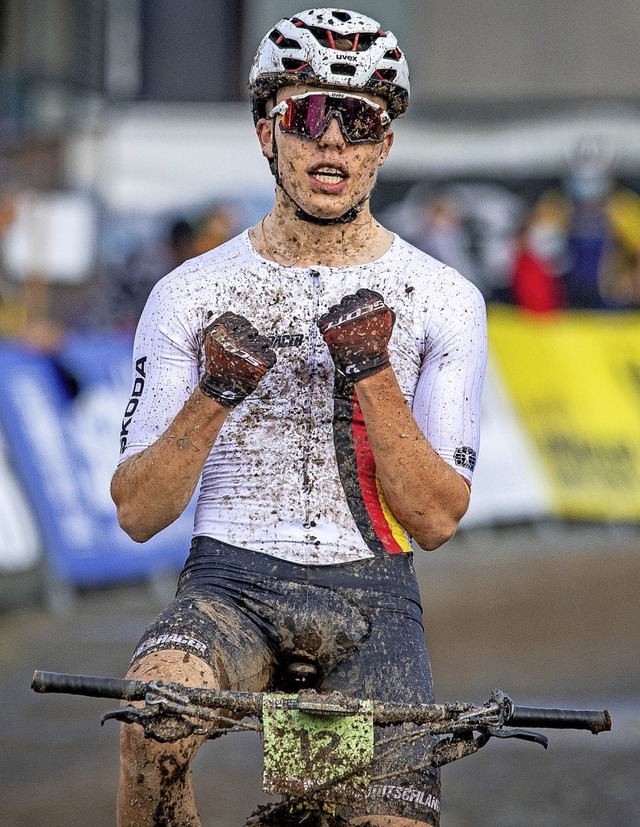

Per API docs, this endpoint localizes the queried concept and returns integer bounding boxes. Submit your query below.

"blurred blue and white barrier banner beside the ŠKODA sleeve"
[0,336,194,586]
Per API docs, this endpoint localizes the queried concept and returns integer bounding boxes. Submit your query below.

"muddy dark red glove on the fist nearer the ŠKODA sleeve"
[200,312,276,408]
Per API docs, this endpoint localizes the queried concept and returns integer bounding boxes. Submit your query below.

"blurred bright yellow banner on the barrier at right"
[489,307,640,520]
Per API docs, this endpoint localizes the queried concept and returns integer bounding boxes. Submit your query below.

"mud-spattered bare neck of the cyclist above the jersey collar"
[250,189,392,267]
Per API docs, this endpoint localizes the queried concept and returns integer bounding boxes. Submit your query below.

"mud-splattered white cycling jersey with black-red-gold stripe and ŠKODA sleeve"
[121,231,486,565]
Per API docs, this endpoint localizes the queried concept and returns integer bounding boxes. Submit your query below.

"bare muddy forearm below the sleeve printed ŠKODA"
[111,388,230,542]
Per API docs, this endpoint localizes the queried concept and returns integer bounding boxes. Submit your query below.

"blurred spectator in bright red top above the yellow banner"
[512,199,566,313]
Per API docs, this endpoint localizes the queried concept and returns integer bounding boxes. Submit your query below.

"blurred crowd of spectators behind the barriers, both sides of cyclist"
[5,135,640,346]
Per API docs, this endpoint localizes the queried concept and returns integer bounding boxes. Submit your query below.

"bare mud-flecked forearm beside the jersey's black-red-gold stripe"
[355,368,469,550]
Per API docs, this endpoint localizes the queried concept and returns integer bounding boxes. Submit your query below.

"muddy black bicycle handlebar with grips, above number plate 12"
[31,671,611,735]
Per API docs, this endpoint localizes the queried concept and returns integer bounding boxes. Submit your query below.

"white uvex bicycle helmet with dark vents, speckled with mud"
[249,9,409,123]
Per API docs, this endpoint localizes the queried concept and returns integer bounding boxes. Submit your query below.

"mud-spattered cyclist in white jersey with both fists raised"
[112,9,486,827]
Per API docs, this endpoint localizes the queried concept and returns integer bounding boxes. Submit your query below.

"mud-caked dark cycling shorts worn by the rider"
[133,537,440,827]
